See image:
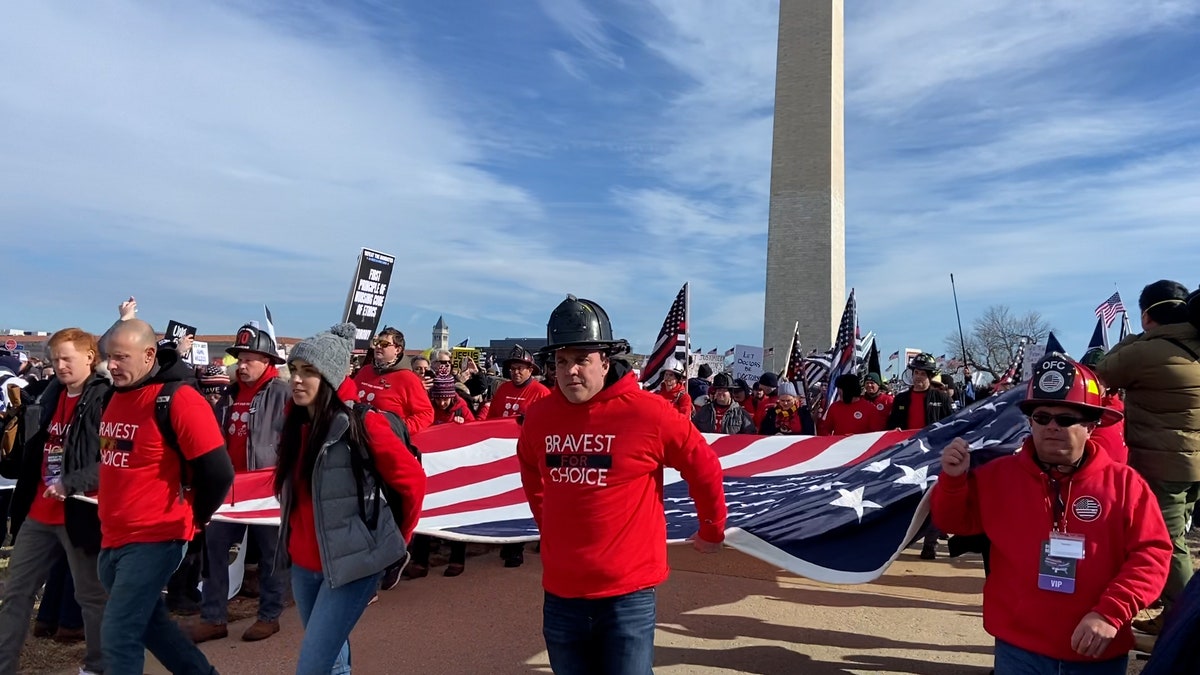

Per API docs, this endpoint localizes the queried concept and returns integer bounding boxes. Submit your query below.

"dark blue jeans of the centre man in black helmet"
[541,589,656,675]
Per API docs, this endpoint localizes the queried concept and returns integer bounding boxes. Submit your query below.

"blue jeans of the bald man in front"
[98,542,216,675]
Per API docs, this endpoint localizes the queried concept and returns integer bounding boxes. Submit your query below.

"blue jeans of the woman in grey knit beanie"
[292,565,383,675]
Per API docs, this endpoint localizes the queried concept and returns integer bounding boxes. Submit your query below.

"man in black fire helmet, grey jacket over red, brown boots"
[191,323,292,644]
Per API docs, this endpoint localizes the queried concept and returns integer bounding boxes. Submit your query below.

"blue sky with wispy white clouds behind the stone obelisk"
[0,0,1200,353]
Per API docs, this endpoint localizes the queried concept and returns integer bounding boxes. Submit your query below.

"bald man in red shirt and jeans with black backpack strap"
[98,318,233,674]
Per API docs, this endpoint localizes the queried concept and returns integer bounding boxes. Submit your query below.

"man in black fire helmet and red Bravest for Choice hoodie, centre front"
[517,295,726,675]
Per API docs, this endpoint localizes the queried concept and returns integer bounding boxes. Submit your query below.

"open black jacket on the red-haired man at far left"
[11,374,113,554]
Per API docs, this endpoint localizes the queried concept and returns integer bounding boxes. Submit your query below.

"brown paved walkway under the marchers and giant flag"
[136,546,991,675]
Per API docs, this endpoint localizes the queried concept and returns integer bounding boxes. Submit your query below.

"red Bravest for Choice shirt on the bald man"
[100,383,224,549]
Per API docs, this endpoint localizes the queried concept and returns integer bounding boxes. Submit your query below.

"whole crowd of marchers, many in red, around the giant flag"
[0,281,1200,675]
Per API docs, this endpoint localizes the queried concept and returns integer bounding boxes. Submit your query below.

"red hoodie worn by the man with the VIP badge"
[932,440,1171,662]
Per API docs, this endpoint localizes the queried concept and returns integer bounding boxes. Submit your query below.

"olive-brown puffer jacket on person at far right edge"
[1096,323,1200,483]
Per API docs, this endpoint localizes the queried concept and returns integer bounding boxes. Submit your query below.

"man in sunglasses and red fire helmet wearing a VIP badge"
[932,353,1171,675]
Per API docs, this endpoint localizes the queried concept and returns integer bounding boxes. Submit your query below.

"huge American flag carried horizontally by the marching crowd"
[187,390,1028,584]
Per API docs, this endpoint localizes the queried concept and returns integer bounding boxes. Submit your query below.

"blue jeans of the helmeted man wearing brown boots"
[200,521,283,623]
